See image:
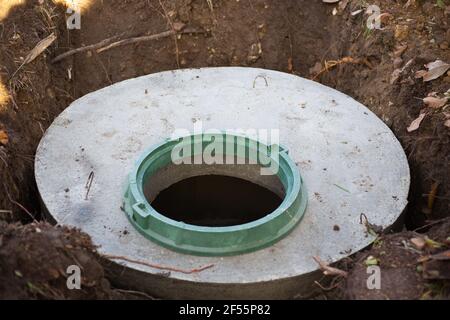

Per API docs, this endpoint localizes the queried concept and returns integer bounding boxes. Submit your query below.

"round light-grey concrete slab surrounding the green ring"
[35,67,410,296]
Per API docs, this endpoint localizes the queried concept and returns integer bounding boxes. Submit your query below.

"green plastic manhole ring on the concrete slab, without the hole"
[123,133,307,256]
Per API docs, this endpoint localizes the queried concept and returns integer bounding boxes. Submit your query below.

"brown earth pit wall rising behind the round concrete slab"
[0,0,450,236]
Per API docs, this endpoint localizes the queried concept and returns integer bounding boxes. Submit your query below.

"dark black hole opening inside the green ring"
[152,175,283,227]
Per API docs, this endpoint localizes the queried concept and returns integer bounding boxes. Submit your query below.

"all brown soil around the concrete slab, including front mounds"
[0,0,450,298]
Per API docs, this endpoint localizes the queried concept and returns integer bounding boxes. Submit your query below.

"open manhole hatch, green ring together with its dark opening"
[124,133,307,256]
